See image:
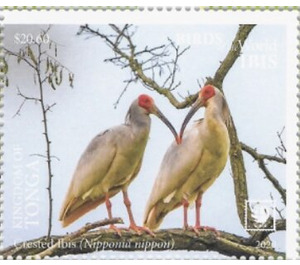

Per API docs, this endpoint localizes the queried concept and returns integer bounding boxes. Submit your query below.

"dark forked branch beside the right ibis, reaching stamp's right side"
[241,142,286,204]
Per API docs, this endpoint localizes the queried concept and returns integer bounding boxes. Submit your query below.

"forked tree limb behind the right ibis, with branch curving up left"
[79,25,284,233]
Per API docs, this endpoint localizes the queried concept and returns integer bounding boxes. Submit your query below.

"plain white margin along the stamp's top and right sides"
[0,7,299,258]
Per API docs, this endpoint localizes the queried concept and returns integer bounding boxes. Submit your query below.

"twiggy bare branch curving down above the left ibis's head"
[79,25,192,109]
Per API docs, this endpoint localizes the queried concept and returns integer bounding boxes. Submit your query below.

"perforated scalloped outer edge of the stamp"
[0,6,300,259]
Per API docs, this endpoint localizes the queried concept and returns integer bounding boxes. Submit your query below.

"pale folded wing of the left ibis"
[60,127,118,220]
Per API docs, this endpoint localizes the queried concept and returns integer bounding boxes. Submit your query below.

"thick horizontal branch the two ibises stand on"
[0,224,284,259]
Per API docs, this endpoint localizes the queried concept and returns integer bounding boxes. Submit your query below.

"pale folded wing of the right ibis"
[144,125,203,220]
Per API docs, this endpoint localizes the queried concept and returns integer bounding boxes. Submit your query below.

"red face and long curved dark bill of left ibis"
[138,94,179,143]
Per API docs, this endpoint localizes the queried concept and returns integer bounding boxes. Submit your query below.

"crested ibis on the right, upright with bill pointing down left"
[144,85,230,234]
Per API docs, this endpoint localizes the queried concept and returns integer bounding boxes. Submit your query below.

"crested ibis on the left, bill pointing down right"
[59,95,178,235]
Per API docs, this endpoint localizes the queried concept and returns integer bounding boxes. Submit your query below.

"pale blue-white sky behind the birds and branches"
[4,25,286,256]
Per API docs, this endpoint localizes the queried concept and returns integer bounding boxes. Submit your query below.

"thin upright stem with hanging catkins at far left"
[4,26,73,238]
